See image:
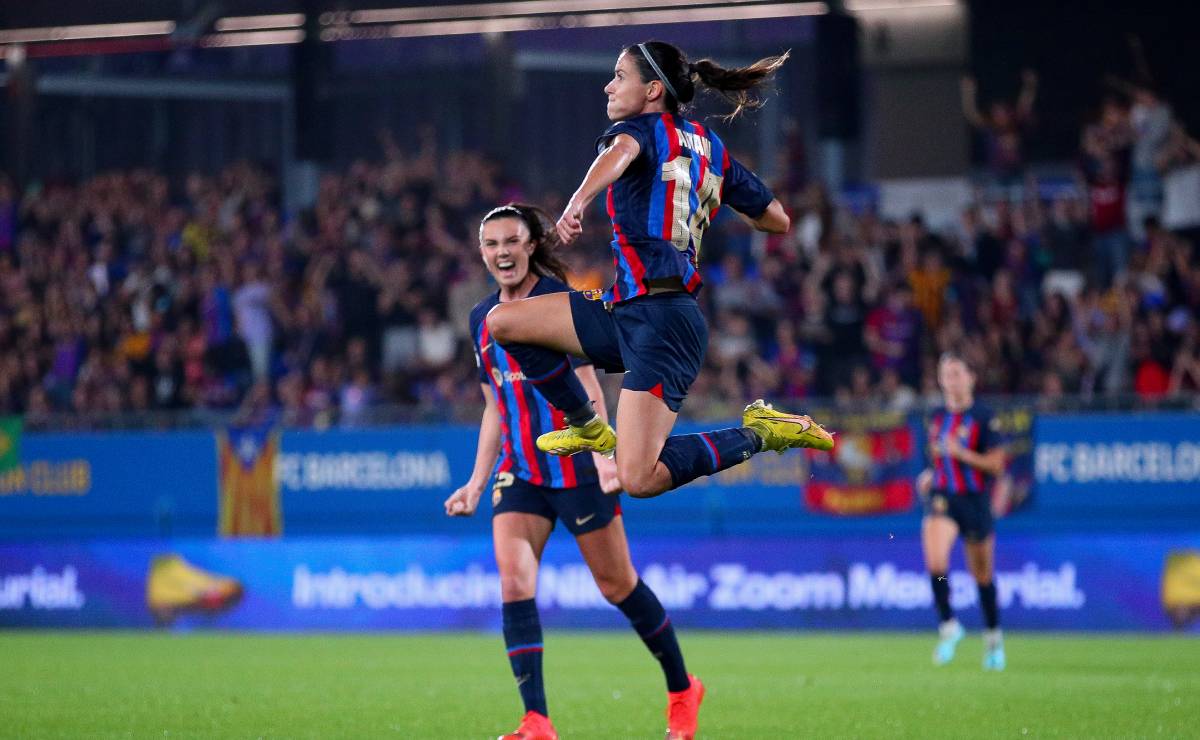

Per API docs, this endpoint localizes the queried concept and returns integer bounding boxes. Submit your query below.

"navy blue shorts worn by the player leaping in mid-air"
[570,291,708,411]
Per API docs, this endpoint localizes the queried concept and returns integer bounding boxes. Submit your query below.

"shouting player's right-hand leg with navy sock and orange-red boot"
[576,517,704,740]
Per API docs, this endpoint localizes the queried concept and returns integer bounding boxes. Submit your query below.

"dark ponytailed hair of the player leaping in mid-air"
[624,41,791,120]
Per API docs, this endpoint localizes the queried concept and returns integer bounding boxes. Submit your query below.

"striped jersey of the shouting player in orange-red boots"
[470,277,598,488]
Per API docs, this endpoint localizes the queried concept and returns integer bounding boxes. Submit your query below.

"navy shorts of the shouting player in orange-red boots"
[492,473,620,536]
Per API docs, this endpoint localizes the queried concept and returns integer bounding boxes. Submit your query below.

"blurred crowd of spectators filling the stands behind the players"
[0,90,1200,425]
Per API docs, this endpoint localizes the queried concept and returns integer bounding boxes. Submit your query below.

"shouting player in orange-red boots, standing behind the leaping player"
[445,205,704,740]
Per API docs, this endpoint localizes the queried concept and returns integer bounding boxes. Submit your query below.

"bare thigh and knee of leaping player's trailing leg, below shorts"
[617,389,677,499]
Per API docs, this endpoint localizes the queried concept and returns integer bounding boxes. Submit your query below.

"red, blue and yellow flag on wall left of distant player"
[804,414,919,516]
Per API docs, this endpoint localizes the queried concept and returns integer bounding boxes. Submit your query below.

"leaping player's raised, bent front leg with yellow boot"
[487,293,616,455]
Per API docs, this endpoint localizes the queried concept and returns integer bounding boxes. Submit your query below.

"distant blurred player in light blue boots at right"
[917,354,1004,670]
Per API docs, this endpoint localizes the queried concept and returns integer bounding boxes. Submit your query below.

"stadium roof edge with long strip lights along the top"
[0,0,958,60]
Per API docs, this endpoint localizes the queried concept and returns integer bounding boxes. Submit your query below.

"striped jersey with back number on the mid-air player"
[596,113,774,303]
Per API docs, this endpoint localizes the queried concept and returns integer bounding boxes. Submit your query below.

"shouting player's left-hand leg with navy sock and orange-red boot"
[492,512,558,740]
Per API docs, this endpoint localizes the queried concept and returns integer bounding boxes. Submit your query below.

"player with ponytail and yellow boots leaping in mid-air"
[487,41,833,498]
